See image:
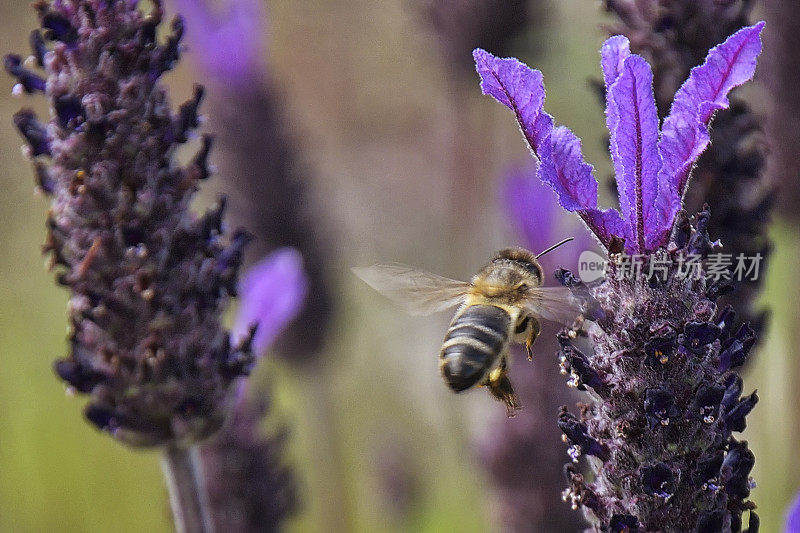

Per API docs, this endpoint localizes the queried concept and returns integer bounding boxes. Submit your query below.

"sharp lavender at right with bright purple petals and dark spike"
[474,23,764,533]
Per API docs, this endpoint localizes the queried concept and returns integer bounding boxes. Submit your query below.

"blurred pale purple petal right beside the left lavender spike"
[231,248,308,355]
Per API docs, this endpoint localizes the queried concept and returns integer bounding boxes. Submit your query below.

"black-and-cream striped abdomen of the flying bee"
[440,305,511,392]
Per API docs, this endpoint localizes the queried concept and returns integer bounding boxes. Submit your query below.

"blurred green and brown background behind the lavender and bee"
[0,0,800,533]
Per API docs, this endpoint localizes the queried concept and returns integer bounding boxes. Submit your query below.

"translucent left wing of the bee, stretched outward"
[352,263,470,315]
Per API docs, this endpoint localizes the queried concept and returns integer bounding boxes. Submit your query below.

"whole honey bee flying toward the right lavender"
[353,238,582,417]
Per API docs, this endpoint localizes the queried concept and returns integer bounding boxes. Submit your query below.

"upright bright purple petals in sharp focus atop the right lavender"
[473,23,764,253]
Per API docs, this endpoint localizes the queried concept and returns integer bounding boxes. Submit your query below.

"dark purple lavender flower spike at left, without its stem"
[6,0,253,449]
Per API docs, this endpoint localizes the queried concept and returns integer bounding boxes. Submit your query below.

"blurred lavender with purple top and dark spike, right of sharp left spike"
[175,0,335,364]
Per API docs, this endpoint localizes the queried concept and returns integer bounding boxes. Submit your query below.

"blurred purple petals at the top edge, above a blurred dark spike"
[175,0,269,86]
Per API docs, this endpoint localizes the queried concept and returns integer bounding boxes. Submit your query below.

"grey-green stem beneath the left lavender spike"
[161,445,214,533]
